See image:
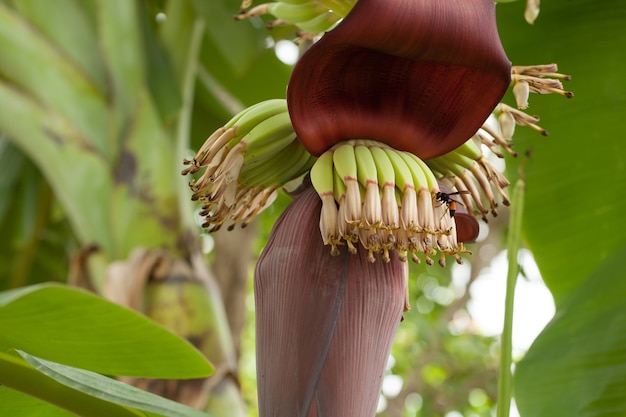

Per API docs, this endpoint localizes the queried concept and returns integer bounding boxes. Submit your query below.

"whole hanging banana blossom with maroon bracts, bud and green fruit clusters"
[188,0,572,416]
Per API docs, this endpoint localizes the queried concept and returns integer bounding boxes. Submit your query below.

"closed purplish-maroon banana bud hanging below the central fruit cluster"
[254,181,407,417]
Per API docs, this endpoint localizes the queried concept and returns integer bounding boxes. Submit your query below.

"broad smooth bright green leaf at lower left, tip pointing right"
[0,284,212,378]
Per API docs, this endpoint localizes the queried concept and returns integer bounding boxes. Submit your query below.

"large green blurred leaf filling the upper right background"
[498,0,626,306]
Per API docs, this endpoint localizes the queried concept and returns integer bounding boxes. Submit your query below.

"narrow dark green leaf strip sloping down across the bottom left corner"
[0,352,141,417]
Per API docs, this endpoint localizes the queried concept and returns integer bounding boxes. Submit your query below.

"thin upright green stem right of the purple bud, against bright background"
[497,178,525,417]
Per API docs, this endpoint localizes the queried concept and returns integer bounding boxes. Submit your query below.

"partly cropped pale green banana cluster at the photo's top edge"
[235,0,355,35]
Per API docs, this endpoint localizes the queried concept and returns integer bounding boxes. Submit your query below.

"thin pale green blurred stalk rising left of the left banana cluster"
[175,19,205,229]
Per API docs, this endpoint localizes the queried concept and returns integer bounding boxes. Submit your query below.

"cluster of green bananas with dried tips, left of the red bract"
[182,99,316,232]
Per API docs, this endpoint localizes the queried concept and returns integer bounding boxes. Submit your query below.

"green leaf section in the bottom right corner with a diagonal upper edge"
[516,247,626,417]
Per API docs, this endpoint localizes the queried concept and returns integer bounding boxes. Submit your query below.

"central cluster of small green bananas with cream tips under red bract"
[310,140,467,265]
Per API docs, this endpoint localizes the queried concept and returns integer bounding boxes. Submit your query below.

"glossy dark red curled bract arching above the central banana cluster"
[287,0,511,160]
